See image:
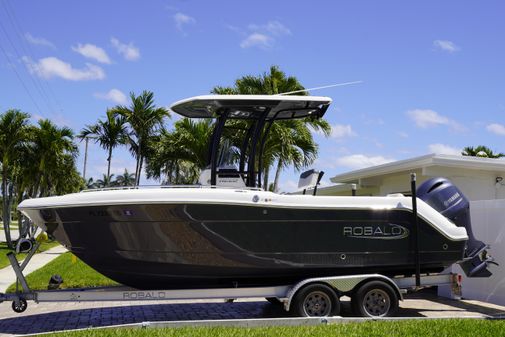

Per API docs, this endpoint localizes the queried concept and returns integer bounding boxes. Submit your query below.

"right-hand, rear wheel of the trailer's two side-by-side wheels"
[351,281,398,317]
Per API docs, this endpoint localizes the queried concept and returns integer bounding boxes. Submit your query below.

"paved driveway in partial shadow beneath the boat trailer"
[0,293,505,335]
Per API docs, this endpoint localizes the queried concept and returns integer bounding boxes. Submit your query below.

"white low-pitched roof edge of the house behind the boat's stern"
[330,154,505,183]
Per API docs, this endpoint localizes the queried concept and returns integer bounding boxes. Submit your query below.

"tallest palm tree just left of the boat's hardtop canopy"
[112,91,170,185]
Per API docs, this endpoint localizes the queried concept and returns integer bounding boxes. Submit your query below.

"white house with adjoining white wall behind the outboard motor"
[317,154,505,305]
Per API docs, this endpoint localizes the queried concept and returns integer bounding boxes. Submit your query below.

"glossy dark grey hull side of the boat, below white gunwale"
[27,203,465,289]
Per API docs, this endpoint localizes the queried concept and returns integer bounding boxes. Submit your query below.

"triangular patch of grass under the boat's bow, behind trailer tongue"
[7,253,118,292]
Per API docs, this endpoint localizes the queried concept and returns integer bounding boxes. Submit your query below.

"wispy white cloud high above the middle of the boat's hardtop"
[238,21,291,49]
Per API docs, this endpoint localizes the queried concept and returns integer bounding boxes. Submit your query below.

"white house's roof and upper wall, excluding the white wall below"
[317,154,505,200]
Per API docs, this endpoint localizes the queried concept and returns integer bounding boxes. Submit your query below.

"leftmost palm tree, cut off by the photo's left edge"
[0,110,30,248]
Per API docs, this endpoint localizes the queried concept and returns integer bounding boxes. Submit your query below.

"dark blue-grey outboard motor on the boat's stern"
[417,178,494,277]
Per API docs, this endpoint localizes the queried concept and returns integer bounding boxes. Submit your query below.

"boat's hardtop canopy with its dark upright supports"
[170,95,332,188]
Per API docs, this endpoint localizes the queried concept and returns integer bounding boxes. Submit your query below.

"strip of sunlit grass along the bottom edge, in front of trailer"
[40,319,505,337]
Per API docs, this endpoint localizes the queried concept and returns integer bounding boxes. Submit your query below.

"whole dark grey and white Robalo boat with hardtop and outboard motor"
[18,95,491,289]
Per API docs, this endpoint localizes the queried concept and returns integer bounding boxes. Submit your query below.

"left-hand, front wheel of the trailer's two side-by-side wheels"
[290,284,340,317]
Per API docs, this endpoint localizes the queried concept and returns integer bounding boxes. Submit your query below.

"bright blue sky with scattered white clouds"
[0,0,505,191]
